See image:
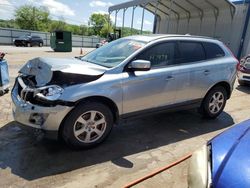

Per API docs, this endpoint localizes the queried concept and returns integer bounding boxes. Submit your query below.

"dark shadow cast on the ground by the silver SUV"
[0,111,234,180]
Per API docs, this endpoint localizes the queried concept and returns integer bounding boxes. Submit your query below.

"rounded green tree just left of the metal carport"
[89,13,111,35]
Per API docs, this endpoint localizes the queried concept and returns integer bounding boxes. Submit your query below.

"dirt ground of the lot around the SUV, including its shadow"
[0,46,250,188]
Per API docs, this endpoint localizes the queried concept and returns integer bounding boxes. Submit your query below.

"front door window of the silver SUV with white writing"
[136,42,176,67]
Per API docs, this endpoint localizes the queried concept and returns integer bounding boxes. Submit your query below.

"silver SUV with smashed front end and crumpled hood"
[12,35,237,148]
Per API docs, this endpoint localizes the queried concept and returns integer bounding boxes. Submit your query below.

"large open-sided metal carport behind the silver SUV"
[108,0,245,54]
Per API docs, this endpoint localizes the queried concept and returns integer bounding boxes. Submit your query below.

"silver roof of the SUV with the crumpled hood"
[126,34,217,42]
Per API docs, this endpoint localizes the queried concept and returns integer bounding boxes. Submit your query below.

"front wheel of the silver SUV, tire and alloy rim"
[61,102,114,149]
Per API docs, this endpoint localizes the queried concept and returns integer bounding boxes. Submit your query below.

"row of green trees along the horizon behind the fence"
[0,5,151,38]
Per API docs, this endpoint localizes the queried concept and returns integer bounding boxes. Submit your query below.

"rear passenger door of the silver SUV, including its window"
[176,40,206,103]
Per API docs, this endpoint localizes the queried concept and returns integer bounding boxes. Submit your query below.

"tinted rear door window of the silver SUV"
[176,41,206,64]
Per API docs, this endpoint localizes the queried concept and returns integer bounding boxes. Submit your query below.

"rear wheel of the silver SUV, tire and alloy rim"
[200,86,227,119]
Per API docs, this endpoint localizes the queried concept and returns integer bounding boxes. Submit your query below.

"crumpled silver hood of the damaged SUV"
[19,57,107,86]
